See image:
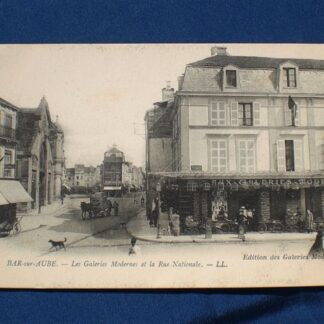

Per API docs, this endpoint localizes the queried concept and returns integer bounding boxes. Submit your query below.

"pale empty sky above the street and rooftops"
[0,44,324,167]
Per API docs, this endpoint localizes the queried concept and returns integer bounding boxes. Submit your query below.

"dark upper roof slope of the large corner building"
[188,55,324,70]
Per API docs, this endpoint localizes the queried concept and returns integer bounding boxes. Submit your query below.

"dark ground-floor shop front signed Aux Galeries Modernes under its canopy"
[148,173,324,234]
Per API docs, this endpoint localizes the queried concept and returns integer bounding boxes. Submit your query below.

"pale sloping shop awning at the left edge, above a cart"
[0,180,33,204]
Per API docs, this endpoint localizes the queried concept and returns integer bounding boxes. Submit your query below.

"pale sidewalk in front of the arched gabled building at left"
[17,198,69,232]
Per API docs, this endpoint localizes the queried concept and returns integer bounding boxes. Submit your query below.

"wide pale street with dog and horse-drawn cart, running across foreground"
[0,197,313,259]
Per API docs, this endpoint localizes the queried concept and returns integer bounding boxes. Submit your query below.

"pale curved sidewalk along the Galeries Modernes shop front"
[126,210,316,243]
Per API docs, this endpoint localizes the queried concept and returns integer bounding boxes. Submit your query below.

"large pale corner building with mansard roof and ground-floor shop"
[150,48,324,233]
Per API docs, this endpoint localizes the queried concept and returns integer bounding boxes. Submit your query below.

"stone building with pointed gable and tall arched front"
[17,98,64,210]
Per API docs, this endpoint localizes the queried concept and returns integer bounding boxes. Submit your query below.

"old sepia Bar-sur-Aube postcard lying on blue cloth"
[0,43,324,289]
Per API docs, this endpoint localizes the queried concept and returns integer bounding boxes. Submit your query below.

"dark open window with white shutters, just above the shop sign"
[277,139,303,172]
